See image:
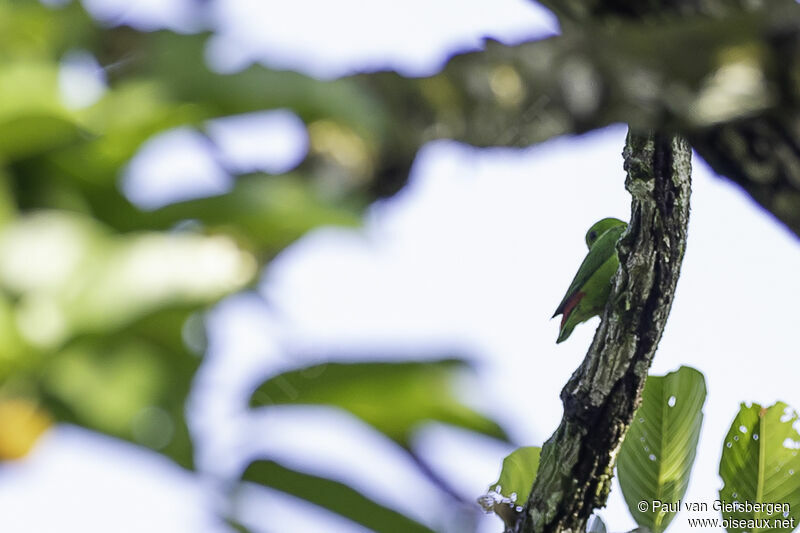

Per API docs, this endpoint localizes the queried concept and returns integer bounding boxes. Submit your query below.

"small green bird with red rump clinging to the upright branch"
[553,218,628,343]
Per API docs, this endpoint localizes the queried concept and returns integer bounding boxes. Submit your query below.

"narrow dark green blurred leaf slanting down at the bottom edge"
[243,461,433,533]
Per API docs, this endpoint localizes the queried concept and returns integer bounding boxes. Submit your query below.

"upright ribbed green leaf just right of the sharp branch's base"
[617,366,706,533]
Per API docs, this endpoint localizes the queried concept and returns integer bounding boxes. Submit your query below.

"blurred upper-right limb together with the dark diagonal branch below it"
[355,2,800,236]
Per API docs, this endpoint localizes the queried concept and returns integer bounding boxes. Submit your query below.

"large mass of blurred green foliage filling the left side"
[0,1,368,466]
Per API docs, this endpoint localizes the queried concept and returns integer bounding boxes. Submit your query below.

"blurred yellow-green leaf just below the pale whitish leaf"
[40,312,200,468]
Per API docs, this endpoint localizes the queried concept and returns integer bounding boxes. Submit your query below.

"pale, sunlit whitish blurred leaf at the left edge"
[0,211,256,342]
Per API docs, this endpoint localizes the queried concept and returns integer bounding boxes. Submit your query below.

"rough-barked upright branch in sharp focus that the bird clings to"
[510,133,691,533]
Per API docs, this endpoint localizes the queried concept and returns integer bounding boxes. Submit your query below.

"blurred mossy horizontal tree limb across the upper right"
[366,6,800,147]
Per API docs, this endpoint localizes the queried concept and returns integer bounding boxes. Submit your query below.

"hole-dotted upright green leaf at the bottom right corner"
[719,402,800,533]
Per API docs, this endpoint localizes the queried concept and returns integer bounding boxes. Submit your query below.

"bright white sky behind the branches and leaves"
[0,0,800,533]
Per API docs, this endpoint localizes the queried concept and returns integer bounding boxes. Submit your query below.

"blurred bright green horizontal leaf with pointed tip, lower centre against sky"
[250,359,507,447]
